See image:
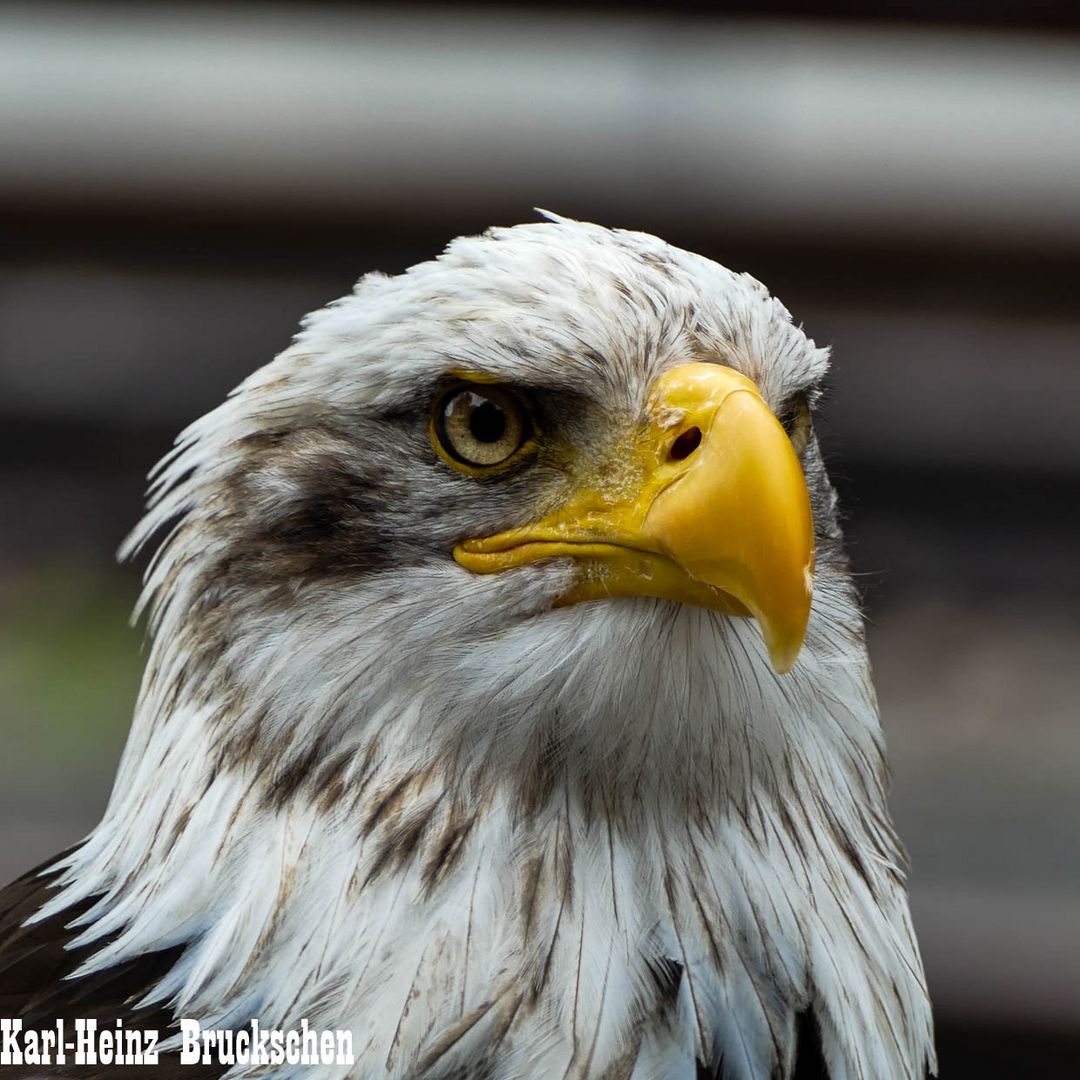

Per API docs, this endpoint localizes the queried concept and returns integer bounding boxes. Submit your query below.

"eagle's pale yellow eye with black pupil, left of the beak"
[433,384,529,469]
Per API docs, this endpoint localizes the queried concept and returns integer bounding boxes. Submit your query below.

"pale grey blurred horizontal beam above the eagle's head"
[6,3,1080,246]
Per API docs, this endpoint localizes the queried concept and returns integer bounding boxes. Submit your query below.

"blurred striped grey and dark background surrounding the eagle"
[0,0,1080,1077]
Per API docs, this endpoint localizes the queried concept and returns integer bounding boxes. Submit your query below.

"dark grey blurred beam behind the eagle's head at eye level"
[0,262,1080,474]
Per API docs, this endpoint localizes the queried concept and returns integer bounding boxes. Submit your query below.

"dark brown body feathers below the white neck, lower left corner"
[0,856,225,1080]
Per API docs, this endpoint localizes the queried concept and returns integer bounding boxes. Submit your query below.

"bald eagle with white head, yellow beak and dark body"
[0,216,936,1080]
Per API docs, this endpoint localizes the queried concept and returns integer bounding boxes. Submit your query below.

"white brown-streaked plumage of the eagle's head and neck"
[12,219,934,1080]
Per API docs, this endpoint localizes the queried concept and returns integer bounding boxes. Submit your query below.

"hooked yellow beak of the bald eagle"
[454,364,813,672]
